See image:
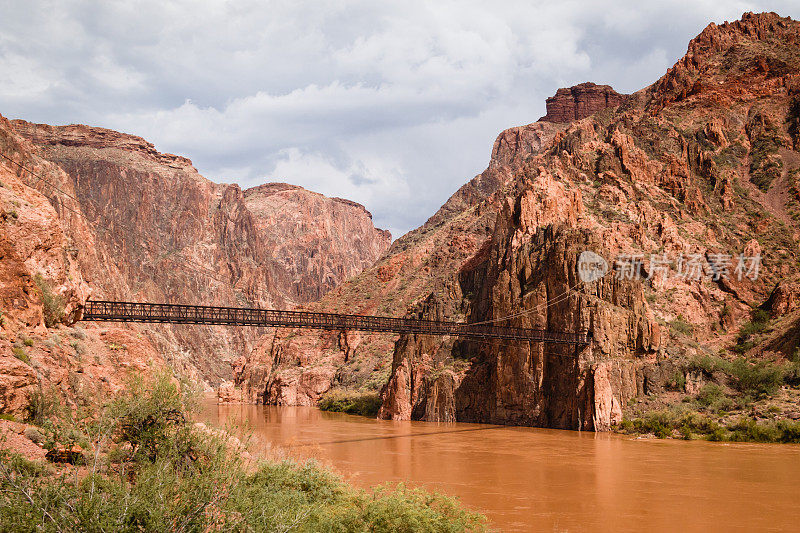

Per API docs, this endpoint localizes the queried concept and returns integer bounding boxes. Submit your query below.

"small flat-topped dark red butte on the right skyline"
[539,82,627,123]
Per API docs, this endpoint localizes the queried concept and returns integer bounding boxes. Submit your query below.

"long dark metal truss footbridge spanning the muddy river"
[82,300,588,345]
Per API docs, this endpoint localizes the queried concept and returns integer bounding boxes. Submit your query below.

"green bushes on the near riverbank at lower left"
[0,375,485,532]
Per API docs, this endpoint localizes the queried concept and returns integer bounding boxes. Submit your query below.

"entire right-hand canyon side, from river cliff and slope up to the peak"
[236,10,800,430]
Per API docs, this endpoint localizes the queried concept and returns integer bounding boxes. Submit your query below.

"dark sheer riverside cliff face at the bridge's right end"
[455,224,660,430]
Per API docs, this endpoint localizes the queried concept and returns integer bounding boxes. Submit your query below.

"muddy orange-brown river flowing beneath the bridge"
[205,405,800,531]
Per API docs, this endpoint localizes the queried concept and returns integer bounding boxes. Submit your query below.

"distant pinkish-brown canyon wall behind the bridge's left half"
[8,121,391,385]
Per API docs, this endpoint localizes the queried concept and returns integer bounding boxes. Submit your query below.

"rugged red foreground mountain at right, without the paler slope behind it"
[379,14,800,430]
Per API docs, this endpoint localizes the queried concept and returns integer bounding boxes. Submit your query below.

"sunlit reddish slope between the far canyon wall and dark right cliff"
[234,80,636,404]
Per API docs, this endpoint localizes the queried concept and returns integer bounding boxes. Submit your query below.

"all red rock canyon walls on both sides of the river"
[0,13,800,431]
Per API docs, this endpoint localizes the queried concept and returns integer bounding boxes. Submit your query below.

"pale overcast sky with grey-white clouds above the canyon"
[0,0,800,237]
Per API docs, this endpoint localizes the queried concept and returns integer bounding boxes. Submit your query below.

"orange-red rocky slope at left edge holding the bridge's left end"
[0,117,175,417]
